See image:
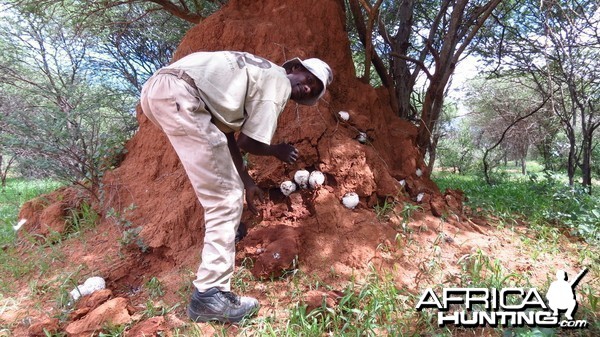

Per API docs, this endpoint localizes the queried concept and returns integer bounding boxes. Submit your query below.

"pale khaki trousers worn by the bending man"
[141,74,244,292]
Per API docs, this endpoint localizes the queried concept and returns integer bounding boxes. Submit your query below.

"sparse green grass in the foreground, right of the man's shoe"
[173,272,440,337]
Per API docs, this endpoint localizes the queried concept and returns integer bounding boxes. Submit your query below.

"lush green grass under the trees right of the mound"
[433,172,600,243]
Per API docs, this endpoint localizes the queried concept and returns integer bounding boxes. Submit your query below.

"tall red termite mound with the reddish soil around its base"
[0,0,596,336]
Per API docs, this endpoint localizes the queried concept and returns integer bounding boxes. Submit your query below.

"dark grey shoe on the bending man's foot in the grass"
[187,288,260,323]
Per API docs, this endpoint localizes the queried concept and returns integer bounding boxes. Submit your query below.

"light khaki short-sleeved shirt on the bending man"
[167,51,292,144]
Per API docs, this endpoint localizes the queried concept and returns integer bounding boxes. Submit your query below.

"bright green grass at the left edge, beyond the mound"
[0,178,62,246]
